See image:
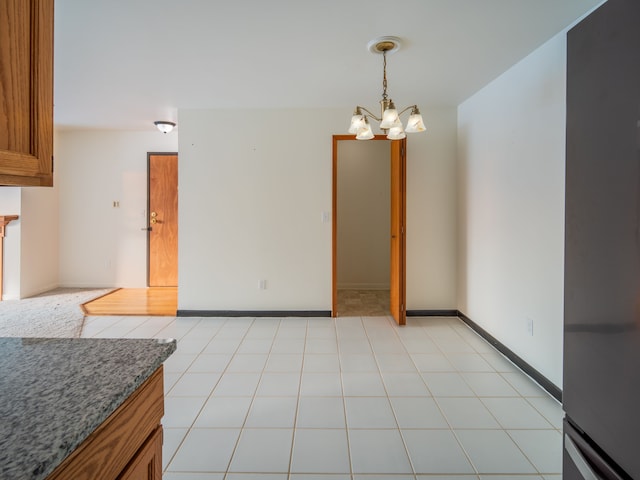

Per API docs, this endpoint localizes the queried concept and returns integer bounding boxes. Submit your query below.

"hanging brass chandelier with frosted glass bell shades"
[349,37,426,140]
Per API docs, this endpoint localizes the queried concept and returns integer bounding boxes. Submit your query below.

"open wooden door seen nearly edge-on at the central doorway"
[389,139,407,325]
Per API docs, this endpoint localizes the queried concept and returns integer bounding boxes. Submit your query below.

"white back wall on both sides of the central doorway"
[178,108,456,311]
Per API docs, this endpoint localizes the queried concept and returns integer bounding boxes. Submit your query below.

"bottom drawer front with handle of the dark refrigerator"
[562,420,629,480]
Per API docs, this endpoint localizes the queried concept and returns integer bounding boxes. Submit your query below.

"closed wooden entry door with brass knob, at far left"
[148,153,178,287]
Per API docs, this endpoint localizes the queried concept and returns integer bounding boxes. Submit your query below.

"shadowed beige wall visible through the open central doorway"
[336,140,391,290]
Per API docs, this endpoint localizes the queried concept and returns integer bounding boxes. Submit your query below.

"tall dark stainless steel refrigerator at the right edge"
[563,0,640,480]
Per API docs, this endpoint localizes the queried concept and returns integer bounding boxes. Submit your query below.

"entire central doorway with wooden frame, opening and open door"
[332,135,406,325]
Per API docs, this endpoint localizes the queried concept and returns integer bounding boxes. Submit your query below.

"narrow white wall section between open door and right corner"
[407,108,458,310]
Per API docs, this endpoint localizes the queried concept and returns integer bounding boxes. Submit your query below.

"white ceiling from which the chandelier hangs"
[54,0,602,130]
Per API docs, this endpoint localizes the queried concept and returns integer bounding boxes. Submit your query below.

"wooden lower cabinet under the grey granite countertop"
[47,367,164,480]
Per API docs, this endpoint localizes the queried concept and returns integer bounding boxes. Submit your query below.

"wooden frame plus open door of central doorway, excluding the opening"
[331,135,407,325]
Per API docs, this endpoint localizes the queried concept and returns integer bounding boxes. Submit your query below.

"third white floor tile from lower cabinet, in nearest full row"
[291,429,351,474]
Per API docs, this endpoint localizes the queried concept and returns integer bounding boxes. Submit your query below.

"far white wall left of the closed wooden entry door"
[55,129,178,287]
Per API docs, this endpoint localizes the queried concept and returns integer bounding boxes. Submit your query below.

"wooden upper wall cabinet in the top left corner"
[0,0,54,186]
